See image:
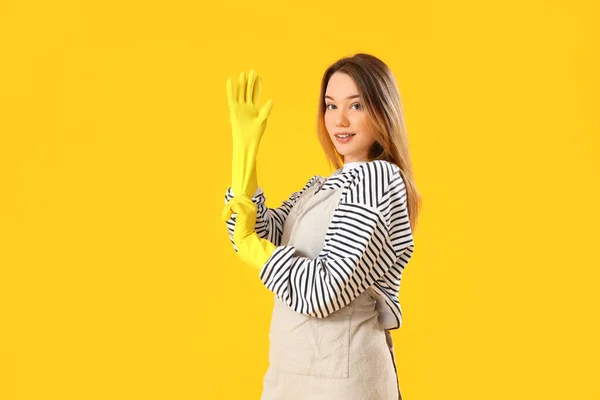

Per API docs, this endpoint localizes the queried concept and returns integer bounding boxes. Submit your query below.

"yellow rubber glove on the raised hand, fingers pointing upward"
[227,70,273,202]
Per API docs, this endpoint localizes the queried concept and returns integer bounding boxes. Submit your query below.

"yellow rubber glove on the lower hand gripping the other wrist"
[228,195,276,271]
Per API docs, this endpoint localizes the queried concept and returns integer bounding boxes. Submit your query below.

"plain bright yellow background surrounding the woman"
[0,0,600,400]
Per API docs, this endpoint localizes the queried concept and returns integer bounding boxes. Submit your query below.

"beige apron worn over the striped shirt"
[261,177,402,400]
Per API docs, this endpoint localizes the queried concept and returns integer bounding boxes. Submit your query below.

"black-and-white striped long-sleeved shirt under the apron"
[225,160,414,330]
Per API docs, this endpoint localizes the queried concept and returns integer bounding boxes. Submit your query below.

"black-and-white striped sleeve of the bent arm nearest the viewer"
[260,169,413,318]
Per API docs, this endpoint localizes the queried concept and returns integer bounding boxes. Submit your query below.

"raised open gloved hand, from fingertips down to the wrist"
[227,69,273,151]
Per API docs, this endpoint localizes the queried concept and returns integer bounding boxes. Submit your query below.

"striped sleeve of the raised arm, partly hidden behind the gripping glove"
[225,175,319,252]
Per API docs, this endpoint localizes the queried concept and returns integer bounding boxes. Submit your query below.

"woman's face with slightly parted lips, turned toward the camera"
[325,72,375,163]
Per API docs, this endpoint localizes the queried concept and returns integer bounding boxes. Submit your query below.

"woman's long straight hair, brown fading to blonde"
[317,53,421,231]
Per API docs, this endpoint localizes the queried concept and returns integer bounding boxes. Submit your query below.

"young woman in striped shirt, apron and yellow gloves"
[222,54,420,400]
